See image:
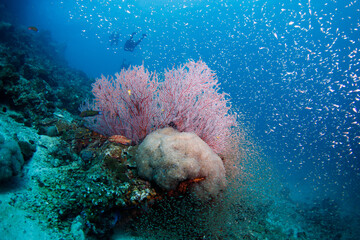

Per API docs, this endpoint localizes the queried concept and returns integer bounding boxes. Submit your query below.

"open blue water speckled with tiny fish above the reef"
[4,0,360,214]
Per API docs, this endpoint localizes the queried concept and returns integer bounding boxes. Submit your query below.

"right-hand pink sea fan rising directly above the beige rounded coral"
[159,60,236,153]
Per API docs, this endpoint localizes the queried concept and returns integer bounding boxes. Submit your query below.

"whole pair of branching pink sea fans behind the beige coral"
[80,60,236,153]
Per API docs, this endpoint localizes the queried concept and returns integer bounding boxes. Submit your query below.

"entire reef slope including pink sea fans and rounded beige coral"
[0,15,360,240]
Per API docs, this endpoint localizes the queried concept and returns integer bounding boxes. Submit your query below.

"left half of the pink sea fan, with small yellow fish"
[80,66,159,142]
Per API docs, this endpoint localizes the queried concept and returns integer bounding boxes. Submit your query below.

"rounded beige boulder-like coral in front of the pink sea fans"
[135,128,226,198]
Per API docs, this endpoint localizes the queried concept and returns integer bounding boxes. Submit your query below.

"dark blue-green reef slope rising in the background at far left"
[0,22,90,126]
